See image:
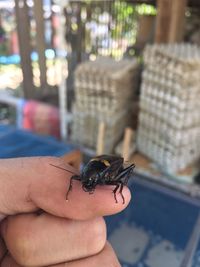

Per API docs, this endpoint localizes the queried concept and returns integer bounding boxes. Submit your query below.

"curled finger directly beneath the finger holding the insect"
[2,213,106,266]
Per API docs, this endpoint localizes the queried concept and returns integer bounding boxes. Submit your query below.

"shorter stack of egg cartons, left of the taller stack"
[72,58,138,153]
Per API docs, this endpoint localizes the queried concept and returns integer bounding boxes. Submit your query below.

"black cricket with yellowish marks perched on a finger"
[51,155,135,204]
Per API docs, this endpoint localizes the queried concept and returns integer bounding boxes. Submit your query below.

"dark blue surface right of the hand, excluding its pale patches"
[106,181,200,267]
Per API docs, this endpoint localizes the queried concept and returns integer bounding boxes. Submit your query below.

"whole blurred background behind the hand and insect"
[0,0,200,267]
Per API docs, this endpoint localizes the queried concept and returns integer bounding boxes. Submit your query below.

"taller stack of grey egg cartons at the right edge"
[137,44,200,173]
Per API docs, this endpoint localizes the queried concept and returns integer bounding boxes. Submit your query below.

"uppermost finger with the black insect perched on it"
[0,157,130,220]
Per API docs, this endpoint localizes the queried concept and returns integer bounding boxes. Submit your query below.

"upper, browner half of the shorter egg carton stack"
[75,58,138,114]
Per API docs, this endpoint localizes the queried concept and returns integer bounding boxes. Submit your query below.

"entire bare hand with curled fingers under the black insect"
[0,157,131,267]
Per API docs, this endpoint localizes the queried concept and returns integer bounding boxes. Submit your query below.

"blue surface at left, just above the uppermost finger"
[0,125,74,158]
